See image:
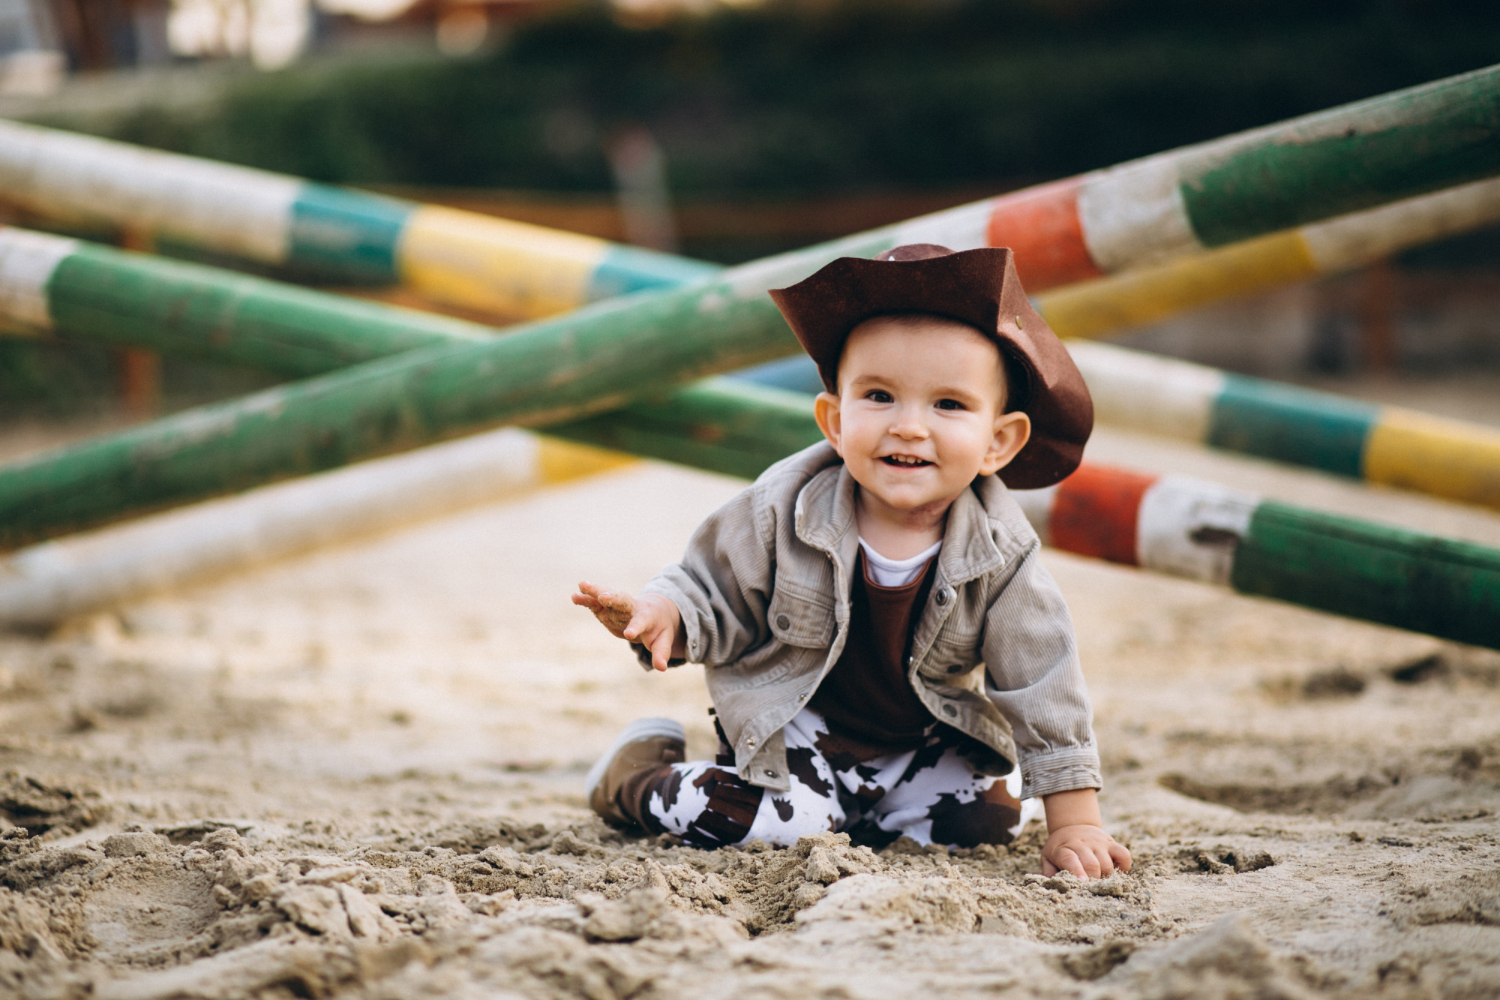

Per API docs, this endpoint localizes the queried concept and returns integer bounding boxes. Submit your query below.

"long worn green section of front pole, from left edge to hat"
[0,274,795,547]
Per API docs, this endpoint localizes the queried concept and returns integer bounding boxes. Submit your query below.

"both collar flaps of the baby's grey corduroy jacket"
[795,458,1022,585]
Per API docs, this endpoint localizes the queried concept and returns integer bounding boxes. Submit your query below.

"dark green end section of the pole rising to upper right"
[1181,66,1500,246]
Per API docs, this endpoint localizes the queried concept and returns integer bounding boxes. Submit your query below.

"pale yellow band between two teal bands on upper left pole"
[396,205,609,319]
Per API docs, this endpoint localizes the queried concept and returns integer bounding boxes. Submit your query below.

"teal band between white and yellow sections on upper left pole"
[287,184,416,285]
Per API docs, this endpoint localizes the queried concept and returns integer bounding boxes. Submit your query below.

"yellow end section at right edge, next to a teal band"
[1364,406,1500,508]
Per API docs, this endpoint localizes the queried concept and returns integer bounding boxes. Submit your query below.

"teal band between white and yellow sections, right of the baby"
[1203,375,1380,480]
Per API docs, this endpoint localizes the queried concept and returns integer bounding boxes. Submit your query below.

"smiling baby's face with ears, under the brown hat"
[818,315,1031,514]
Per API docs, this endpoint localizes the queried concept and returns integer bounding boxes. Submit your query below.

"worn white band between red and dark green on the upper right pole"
[1079,153,1203,274]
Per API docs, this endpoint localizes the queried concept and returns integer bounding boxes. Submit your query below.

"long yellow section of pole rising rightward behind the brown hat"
[1037,229,1317,337]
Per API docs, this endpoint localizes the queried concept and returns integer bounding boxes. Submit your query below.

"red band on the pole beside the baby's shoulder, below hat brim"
[1047,465,1160,565]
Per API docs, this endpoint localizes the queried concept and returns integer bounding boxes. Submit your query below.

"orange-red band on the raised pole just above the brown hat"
[990,177,1104,292]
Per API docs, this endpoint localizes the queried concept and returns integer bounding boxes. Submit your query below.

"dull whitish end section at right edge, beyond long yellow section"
[1301,177,1500,273]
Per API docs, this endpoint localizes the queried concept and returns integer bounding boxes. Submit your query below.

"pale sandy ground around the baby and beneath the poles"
[0,401,1500,1000]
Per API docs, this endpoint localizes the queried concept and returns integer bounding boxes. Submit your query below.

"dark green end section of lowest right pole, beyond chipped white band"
[1230,501,1500,648]
